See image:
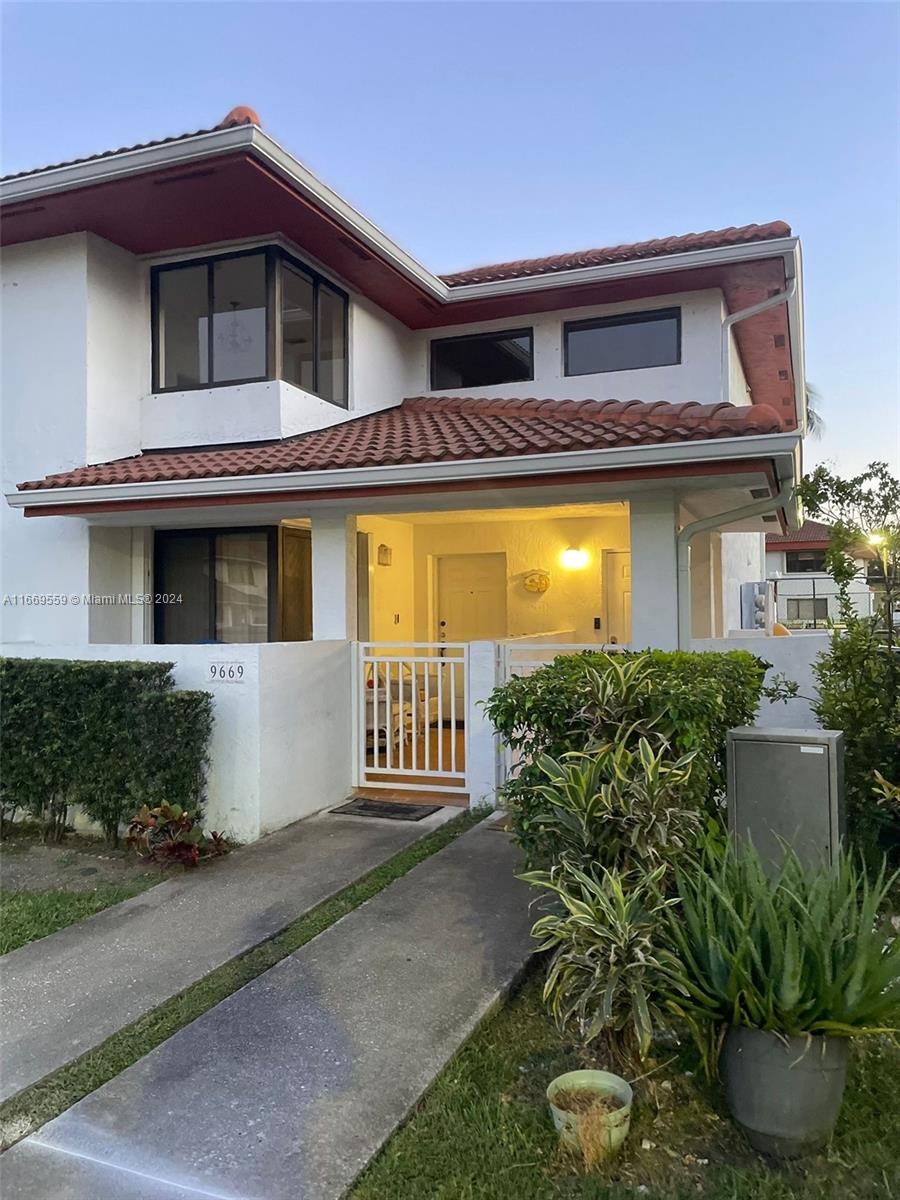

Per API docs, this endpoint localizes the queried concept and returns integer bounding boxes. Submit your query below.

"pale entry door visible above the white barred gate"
[437,554,506,642]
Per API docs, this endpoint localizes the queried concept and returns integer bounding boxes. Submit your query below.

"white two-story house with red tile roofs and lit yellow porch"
[0,108,805,833]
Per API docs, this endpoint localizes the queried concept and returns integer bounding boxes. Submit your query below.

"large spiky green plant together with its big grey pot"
[666,847,900,1158]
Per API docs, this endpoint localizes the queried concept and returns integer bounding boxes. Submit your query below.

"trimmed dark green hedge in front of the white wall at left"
[0,659,212,844]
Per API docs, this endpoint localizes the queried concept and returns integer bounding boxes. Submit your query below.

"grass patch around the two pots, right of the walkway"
[350,972,900,1200]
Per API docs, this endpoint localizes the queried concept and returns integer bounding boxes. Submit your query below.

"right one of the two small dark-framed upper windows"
[563,308,682,376]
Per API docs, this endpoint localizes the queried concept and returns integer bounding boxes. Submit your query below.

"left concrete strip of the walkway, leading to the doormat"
[0,809,456,1100]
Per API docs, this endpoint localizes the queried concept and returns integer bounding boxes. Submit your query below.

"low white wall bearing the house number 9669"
[1,642,350,841]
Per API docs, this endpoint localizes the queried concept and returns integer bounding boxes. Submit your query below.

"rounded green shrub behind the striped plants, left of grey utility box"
[485,650,768,862]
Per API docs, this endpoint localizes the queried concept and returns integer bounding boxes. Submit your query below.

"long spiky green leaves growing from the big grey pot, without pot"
[666,846,900,1075]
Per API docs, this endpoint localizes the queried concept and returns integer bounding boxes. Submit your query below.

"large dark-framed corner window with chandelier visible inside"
[151,248,348,407]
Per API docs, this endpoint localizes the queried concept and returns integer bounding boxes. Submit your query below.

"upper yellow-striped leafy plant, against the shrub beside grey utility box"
[535,737,704,872]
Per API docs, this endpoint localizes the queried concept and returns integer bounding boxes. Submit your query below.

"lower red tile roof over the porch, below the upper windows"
[19,396,781,490]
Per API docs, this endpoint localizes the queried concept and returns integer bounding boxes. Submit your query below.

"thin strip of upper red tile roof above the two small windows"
[440,221,791,288]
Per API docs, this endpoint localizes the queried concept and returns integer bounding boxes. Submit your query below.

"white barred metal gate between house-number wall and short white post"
[353,642,469,793]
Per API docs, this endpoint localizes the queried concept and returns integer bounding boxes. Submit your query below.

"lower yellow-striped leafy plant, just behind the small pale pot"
[522,863,677,1066]
